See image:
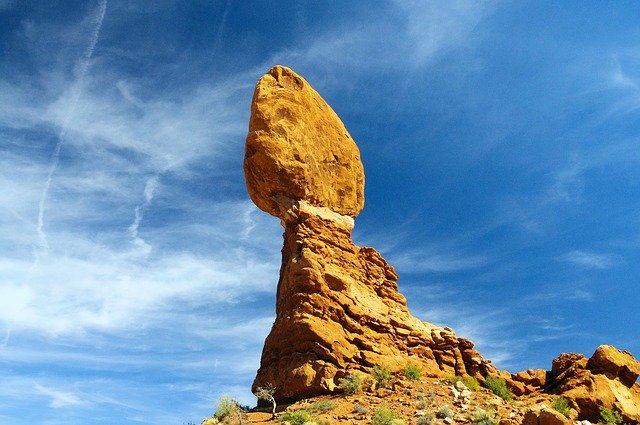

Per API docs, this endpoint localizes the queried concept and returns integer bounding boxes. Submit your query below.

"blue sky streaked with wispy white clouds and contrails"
[0,0,640,425]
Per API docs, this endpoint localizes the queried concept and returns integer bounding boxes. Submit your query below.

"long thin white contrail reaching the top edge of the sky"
[37,0,107,252]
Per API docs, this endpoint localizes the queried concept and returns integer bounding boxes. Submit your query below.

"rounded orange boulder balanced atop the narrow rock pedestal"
[244,65,364,219]
